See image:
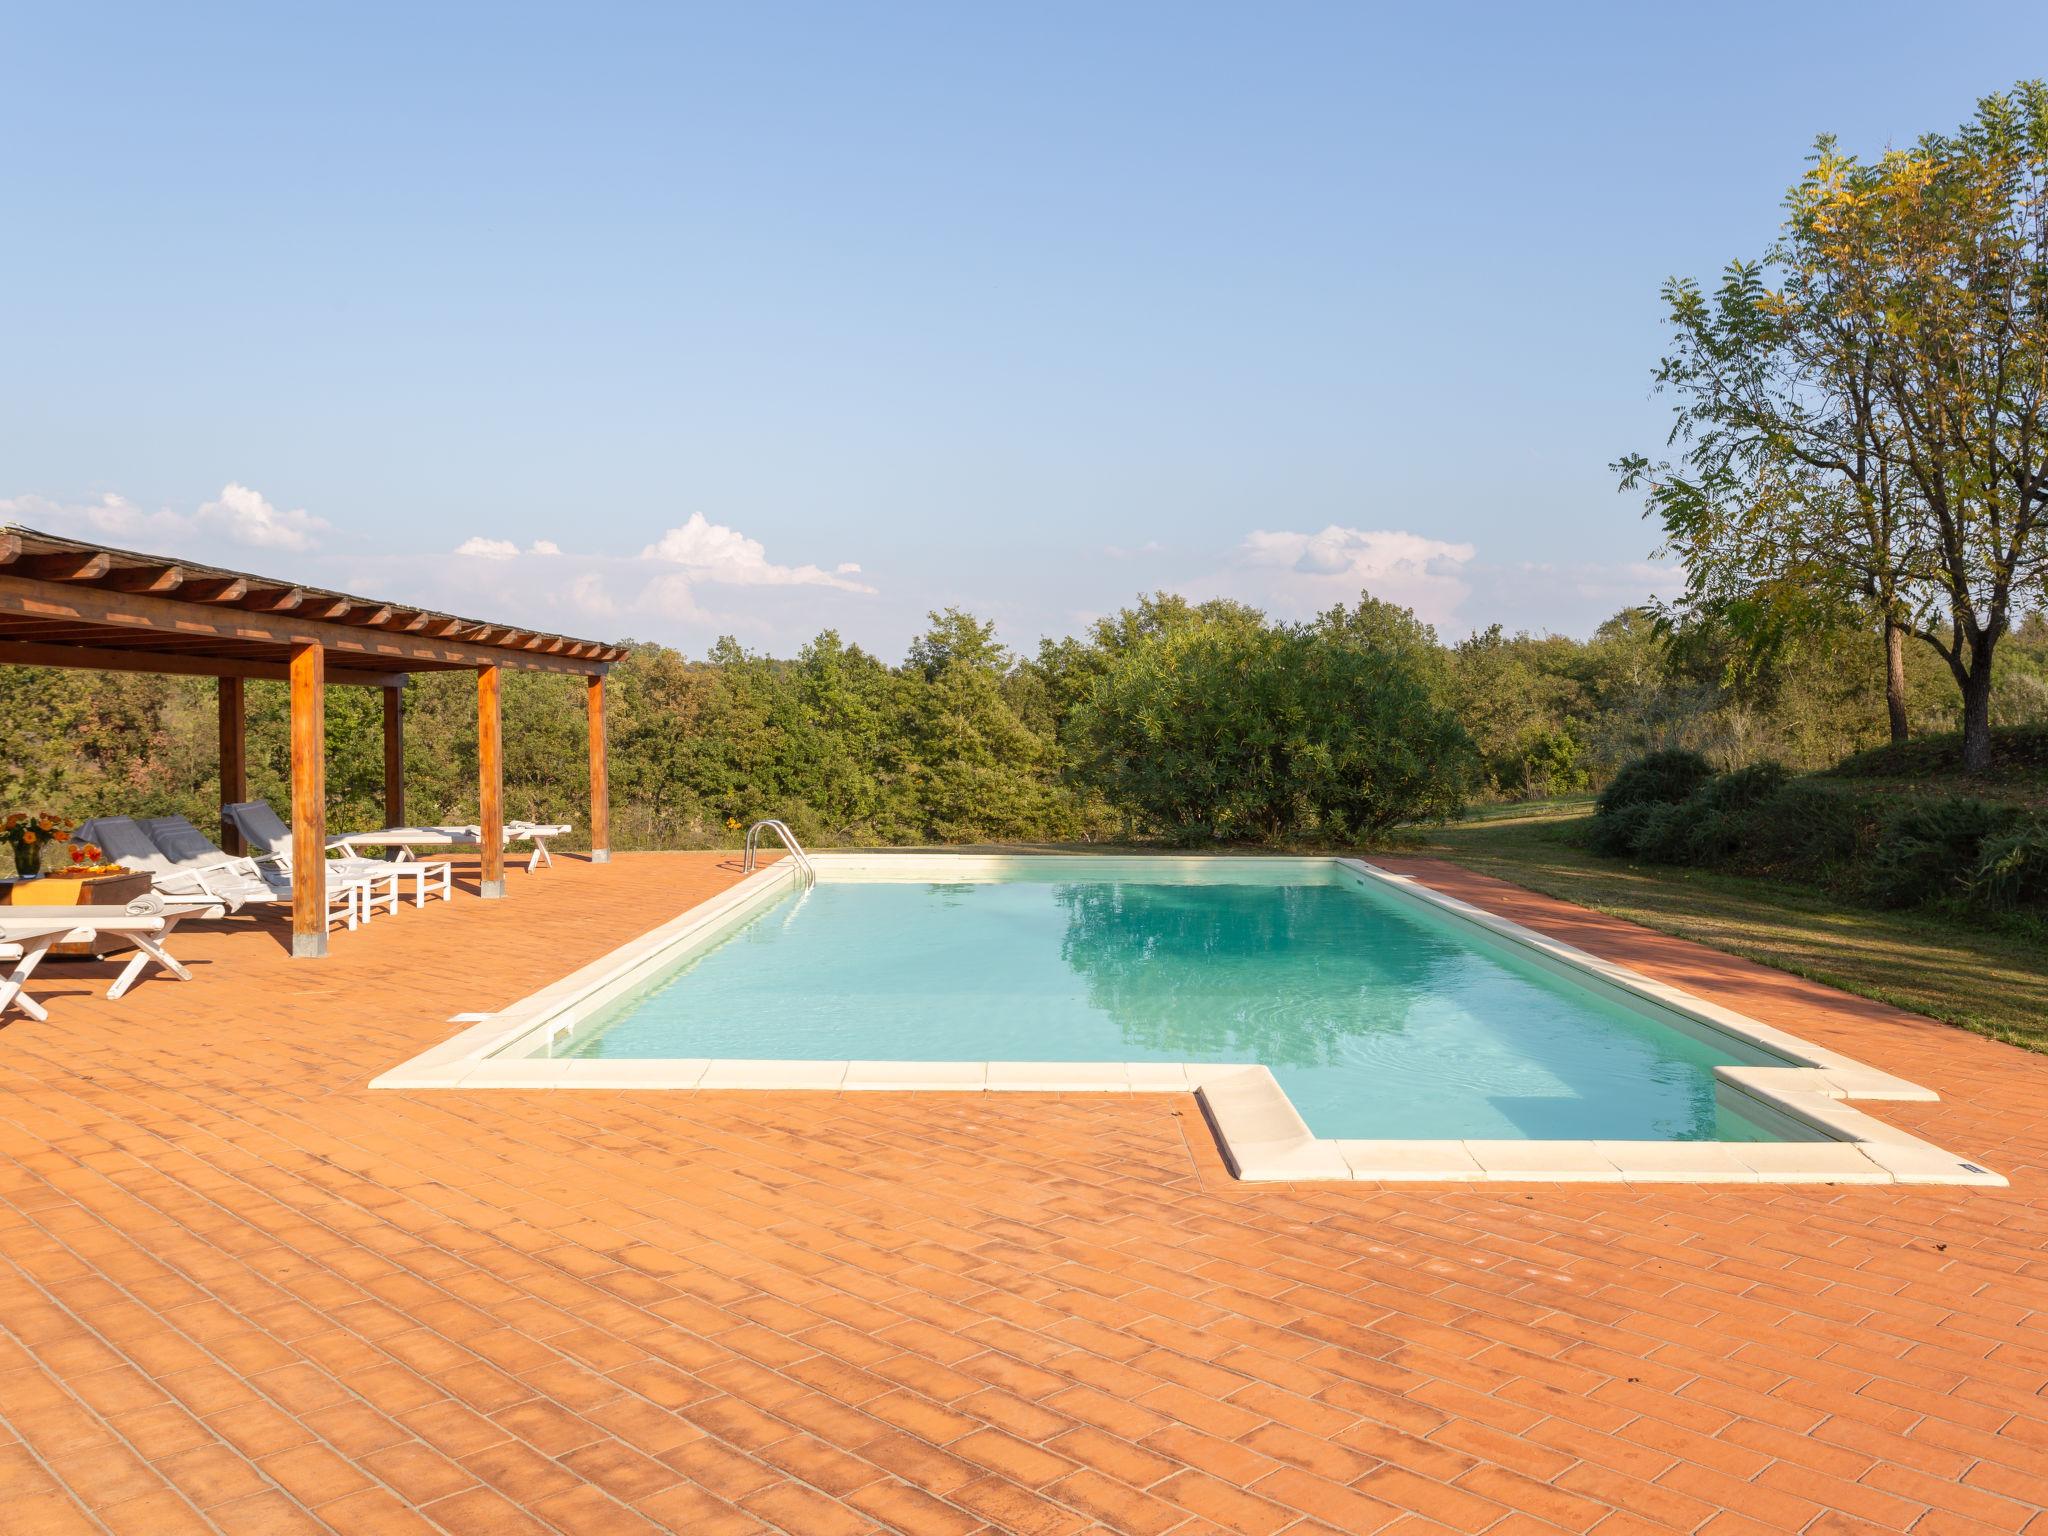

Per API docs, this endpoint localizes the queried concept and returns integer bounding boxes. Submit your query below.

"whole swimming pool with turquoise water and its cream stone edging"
[373,854,2003,1184]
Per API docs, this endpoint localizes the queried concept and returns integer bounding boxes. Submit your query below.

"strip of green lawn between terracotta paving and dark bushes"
[1415,801,2048,1053]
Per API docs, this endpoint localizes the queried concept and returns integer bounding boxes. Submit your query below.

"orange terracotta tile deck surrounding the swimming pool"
[0,854,2048,1536]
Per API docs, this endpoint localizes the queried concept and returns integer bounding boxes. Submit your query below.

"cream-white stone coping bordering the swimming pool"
[371,854,2005,1186]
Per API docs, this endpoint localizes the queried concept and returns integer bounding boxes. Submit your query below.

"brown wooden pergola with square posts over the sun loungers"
[0,524,625,956]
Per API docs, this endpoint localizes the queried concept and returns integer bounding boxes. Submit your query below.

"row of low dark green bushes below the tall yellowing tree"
[1589,752,2048,907]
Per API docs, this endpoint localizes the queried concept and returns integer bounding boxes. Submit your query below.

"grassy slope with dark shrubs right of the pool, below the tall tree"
[1421,727,2048,1051]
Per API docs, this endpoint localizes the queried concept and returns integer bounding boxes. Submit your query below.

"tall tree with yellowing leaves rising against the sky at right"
[1618,82,2048,772]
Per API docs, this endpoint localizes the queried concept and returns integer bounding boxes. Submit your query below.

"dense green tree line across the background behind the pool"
[0,594,2048,848]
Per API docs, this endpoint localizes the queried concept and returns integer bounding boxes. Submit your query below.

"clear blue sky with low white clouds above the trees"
[0,4,2048,657]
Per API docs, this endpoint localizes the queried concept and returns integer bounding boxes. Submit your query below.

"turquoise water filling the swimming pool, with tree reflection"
[557,862,1784,1141]
